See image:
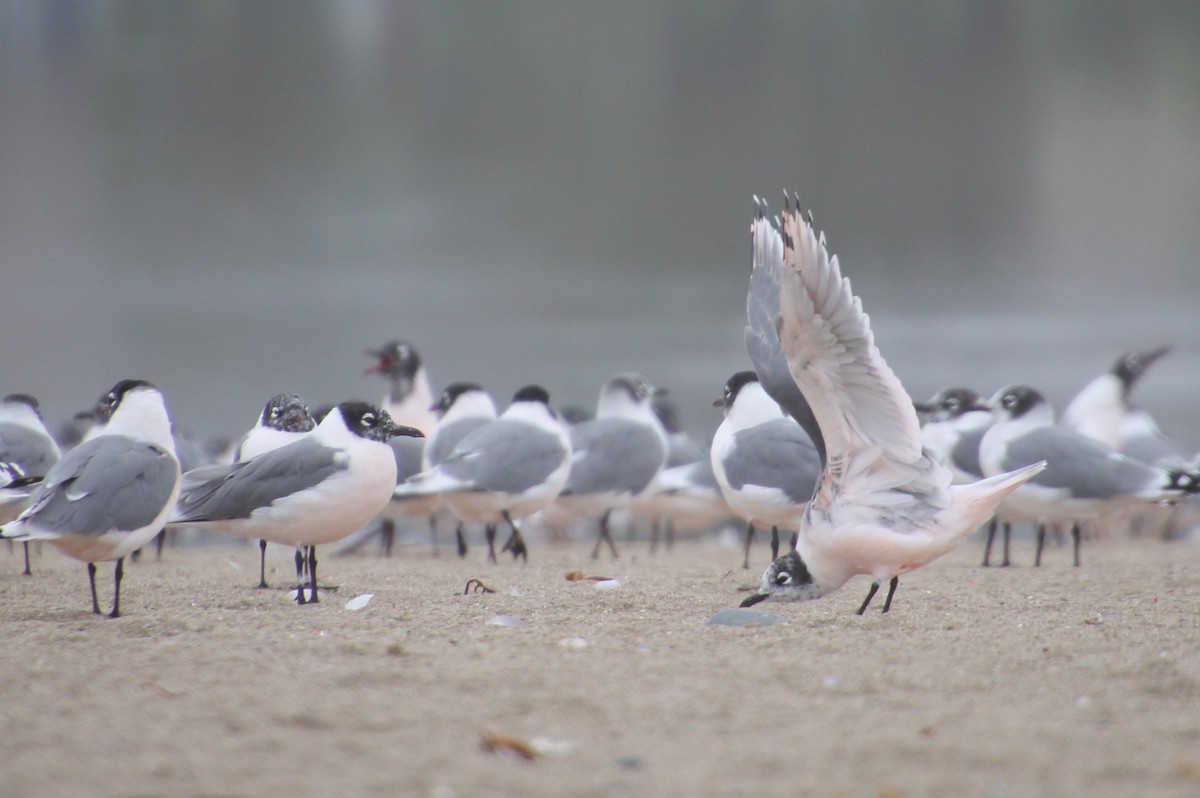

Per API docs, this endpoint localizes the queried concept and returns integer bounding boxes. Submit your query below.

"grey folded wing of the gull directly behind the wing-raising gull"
[721,419,822,504]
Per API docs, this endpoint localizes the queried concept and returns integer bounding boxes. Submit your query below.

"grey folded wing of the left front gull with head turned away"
[25,436,179,535]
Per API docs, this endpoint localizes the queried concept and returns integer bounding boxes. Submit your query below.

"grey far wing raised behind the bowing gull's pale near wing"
[743,197,826,462]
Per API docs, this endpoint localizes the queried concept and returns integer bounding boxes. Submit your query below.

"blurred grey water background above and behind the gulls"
[0,0,1200,450]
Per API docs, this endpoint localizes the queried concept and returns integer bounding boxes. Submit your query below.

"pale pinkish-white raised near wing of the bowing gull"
[756,198,926,494]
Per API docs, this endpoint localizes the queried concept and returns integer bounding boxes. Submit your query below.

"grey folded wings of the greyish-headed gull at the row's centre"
[563,419,667,494]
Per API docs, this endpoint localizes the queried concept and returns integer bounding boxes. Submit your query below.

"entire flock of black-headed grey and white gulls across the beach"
[0,199,1200,618]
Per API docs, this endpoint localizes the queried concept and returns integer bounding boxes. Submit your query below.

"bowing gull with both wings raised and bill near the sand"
[742,203,1045,614]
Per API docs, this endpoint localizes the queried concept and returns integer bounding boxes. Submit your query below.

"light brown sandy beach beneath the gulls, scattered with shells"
[0,528,1200,798]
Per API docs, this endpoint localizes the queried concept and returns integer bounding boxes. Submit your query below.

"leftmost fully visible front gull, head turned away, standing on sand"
[4,379,179,618]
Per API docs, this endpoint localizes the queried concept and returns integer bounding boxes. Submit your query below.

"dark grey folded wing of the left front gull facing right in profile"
[172,438,346,524]
